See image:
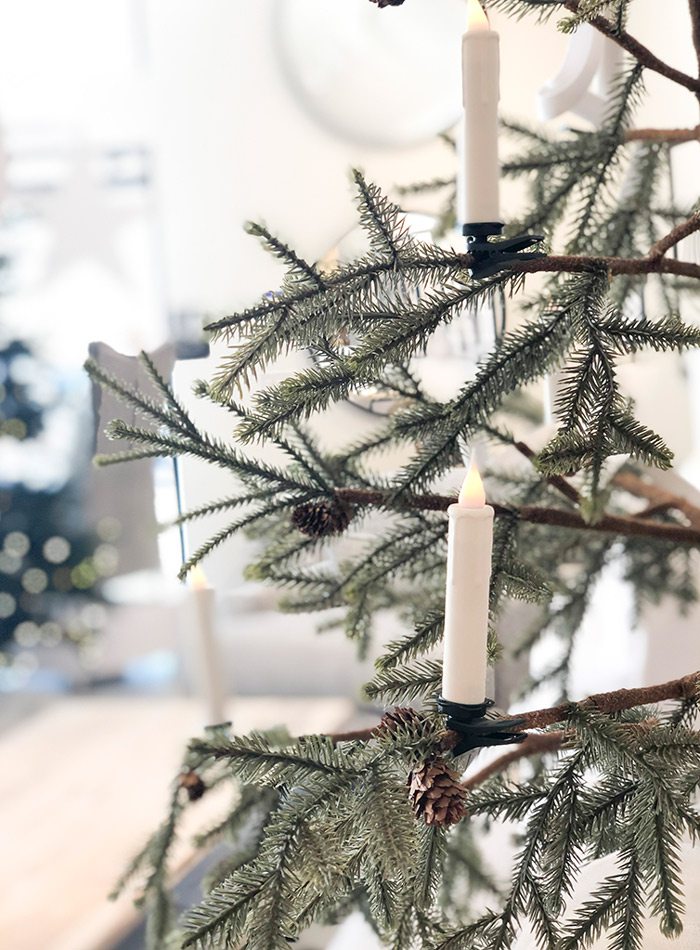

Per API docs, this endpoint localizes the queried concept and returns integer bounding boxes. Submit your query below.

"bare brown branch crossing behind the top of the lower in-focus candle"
[336,488,700,545]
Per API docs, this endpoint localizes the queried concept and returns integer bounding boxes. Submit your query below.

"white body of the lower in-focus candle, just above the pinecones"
[442,504,493,704]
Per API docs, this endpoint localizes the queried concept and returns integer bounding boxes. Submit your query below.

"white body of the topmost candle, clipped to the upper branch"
[458,30,501,224]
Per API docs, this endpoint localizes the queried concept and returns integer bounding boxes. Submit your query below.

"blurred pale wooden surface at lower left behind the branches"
[0,697,352,950]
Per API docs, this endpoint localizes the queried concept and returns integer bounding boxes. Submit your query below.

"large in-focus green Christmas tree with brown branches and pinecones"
[88,0,700,950]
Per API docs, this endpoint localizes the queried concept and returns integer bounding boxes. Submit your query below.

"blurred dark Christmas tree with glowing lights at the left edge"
[0,340,108,679]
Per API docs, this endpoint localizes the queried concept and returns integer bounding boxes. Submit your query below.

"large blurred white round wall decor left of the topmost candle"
[272,0,467,147]
